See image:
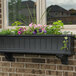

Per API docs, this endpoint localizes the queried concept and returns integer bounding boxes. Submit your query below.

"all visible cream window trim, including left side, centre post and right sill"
[2,0,76,33]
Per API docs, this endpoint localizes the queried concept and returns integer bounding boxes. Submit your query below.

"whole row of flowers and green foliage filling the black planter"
[0,20,63,35]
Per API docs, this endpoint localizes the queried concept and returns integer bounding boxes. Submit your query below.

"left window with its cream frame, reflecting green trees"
[2,0,46,29]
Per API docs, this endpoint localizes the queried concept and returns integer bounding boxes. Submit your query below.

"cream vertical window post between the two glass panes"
[37,0,46,25]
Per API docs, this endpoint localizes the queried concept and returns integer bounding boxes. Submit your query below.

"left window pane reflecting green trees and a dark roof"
[8,0,36,26]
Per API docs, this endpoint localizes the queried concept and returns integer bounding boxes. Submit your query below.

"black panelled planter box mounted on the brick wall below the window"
[0,35,74,64]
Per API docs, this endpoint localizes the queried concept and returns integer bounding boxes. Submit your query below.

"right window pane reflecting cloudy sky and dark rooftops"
[46,0,76,24]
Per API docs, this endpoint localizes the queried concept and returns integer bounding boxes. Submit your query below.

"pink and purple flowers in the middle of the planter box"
[18,23,47,35]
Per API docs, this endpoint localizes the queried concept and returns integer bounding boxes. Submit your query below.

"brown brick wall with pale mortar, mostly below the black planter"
[0,0,76,76]
